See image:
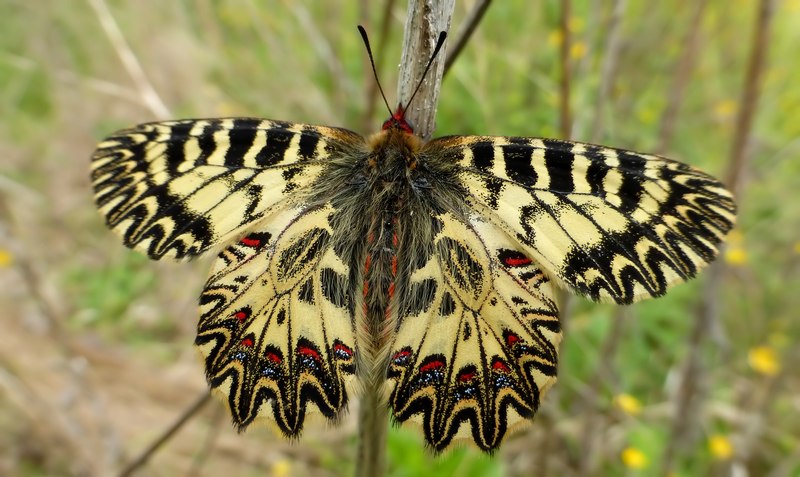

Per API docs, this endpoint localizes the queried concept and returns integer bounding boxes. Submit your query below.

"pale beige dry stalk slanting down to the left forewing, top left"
[87,0,170,119]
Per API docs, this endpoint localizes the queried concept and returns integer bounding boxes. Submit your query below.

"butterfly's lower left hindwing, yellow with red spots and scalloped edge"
[196,206,355,436]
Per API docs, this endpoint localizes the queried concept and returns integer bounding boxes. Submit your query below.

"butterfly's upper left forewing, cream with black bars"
[92,118,364,259]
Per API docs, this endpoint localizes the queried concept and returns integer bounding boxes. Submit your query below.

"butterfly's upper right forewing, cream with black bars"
[423,136,736,303]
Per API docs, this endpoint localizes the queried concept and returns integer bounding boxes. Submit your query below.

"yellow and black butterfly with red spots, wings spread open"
[91,26,736,452]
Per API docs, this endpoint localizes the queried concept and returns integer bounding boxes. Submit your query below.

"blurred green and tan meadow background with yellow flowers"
[0,0,800,477]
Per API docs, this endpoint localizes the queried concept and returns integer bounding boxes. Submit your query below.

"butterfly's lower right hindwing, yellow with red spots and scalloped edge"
[388,213,561,451]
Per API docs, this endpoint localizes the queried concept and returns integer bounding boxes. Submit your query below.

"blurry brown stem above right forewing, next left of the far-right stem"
[656,0,708,154]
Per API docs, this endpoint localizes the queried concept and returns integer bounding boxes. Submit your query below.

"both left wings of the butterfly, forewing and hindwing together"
[92,118,365,436]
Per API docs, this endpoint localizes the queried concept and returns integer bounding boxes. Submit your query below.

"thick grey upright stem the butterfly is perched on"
[356,0,454,477]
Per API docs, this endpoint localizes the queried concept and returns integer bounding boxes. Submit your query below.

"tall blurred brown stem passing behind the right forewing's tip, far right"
[661,0,775,475]
